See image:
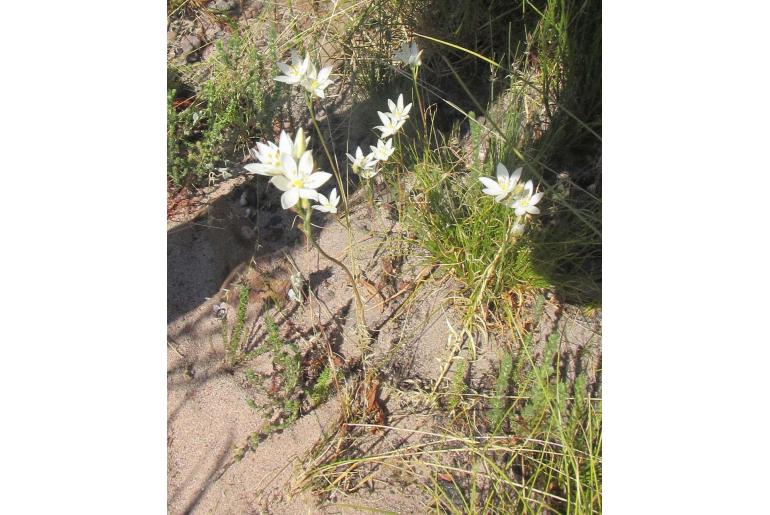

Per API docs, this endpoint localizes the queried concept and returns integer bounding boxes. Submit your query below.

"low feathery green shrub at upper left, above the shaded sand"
[167,30,282,187]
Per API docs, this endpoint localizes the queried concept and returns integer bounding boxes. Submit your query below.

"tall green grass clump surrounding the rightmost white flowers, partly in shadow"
[384,0,601,308]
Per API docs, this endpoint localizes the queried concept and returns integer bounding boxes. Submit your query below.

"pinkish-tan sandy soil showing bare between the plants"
[168,172,600,514]
